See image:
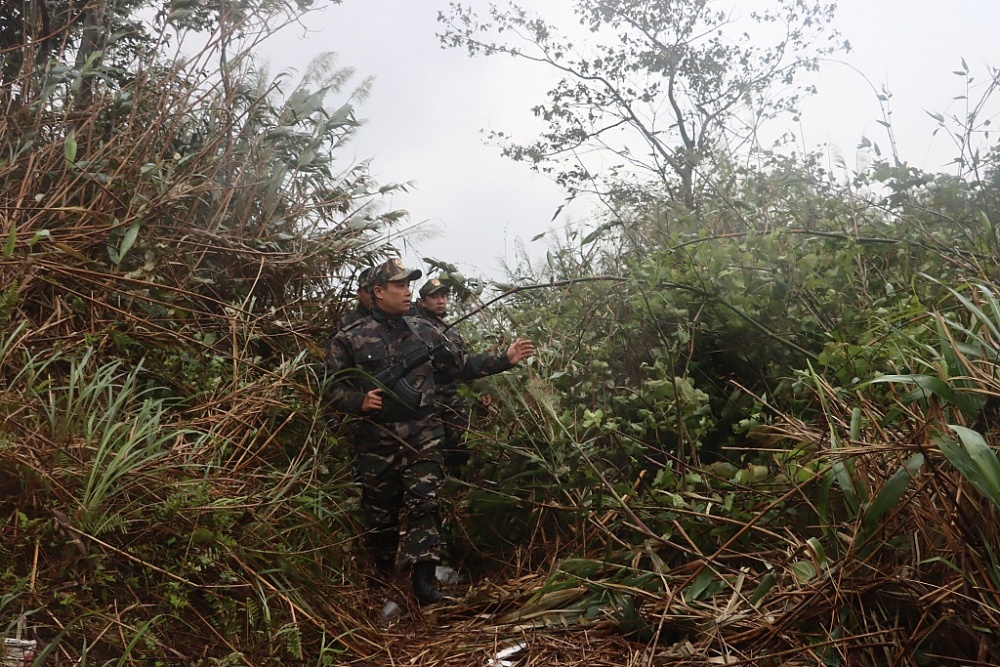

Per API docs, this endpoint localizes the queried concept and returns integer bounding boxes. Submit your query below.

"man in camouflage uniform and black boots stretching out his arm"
[327,259,535,604]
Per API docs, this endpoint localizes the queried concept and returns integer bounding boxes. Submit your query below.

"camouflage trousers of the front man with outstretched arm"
[355,418,444,566]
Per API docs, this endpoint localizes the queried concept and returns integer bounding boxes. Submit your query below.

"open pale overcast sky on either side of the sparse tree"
[261,0,1000,278]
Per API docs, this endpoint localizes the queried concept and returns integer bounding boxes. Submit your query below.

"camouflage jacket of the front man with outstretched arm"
[326,308,511,421]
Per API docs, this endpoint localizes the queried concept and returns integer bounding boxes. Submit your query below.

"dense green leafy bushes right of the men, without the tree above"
[450,58,1000,660]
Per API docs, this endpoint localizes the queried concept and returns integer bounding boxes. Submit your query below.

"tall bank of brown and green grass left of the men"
[0,2,403,664]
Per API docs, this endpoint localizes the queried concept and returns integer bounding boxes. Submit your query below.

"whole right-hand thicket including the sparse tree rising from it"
[442,0,1000,665]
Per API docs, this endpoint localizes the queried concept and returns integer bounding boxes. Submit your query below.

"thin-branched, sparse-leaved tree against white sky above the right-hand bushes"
[439,0,849,208]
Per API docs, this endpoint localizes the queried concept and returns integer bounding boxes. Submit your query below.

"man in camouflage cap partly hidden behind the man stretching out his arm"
[417,278,472,474]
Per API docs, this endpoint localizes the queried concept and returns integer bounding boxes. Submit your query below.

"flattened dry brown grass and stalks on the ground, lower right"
[332,388,1000,666]
